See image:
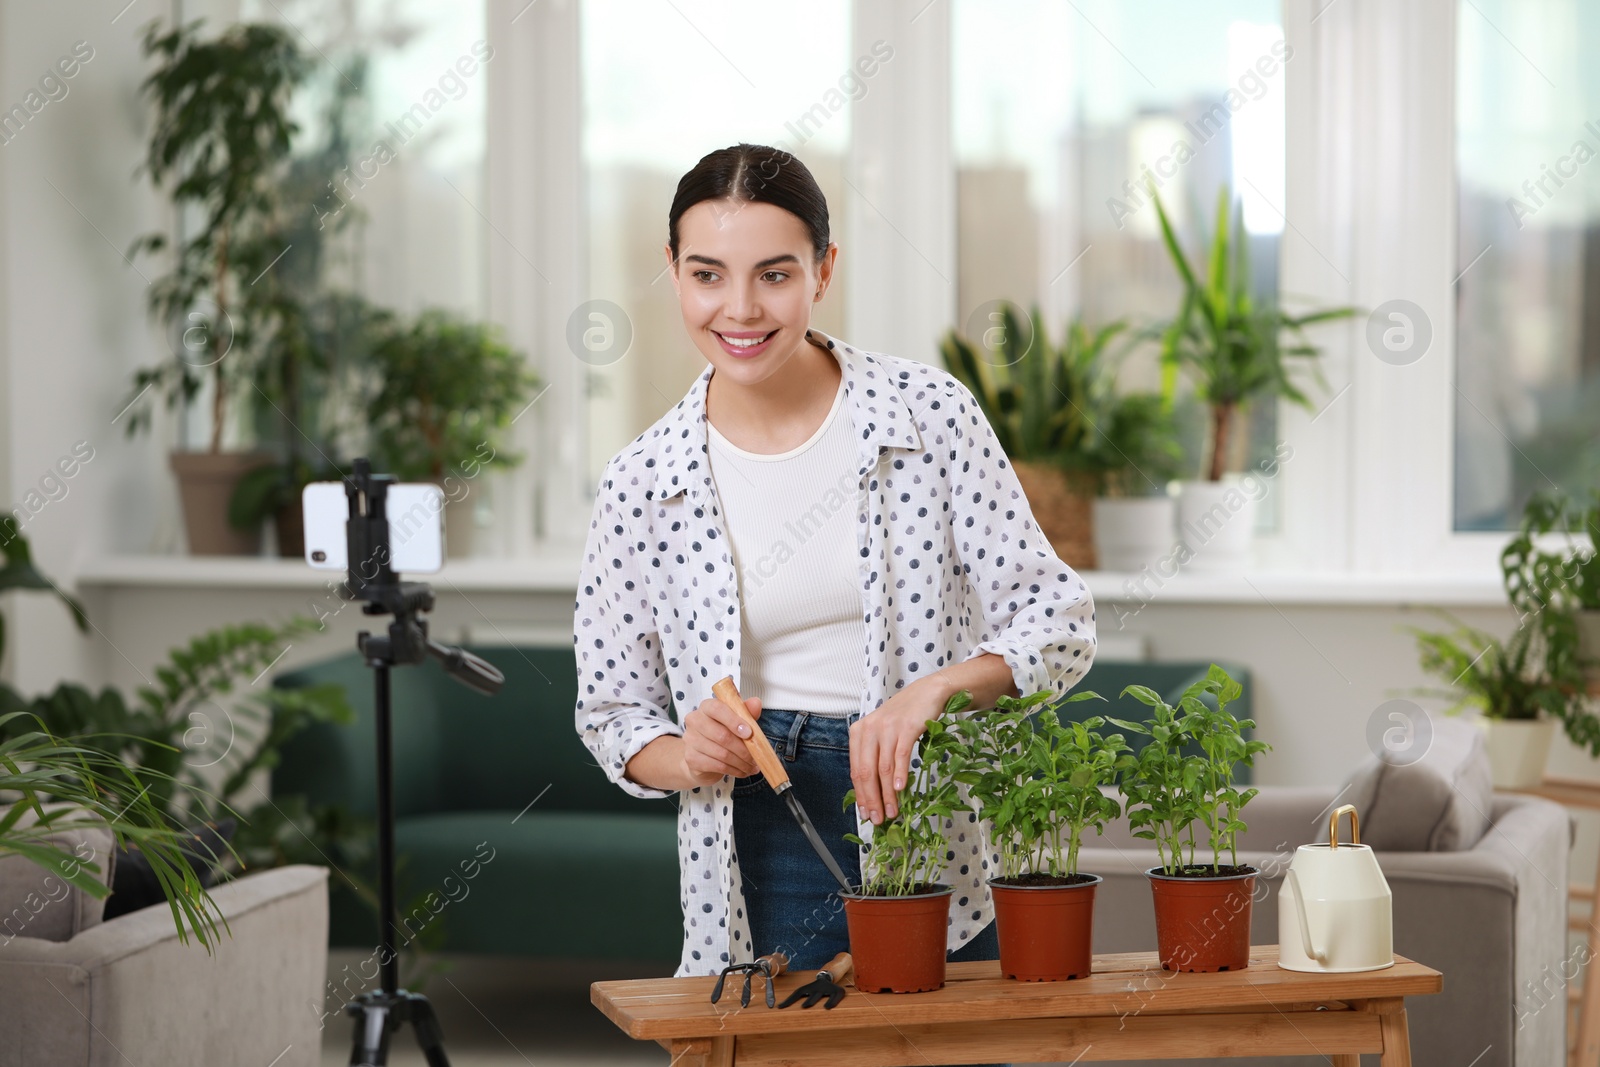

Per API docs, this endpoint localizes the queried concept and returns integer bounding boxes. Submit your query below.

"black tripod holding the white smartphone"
[341,458,506,1067]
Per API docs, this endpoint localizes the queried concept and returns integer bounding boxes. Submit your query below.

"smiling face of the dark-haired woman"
[666,200,838,386]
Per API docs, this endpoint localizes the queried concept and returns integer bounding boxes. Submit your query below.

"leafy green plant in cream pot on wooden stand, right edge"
[1406,611,1600,789]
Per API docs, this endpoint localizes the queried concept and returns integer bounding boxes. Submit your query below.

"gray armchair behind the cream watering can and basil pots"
[1078,785,1571,1067]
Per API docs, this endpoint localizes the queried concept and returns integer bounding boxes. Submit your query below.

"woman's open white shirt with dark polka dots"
[573,330,1094,976]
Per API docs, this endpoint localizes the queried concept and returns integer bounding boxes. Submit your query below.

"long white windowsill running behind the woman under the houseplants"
[78,549,1506,608]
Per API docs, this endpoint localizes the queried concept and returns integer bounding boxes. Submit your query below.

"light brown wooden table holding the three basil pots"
[589,945,1443,1067]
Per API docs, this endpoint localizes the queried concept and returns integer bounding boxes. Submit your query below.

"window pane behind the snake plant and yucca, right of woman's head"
[950,0,1286,525]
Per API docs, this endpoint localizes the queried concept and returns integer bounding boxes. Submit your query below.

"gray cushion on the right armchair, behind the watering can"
[1339,717,1494,853]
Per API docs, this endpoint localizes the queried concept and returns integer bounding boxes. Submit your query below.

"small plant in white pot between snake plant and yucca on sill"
[1093,394,1182,571]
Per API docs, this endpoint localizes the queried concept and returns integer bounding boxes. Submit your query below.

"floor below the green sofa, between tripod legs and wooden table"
[322,949,672,1067]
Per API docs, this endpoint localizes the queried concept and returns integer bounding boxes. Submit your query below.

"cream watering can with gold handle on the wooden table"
[1278,805,1395,973]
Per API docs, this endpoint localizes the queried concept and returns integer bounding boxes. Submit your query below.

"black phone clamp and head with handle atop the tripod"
[341,456,506,696]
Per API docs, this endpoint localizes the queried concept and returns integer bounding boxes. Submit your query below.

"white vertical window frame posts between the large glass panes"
[486,0,1506,577]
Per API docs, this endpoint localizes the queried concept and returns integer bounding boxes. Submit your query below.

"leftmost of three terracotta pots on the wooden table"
[840,885,954,993]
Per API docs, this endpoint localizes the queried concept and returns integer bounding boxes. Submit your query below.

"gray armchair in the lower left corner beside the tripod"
[0,833,328,1067]
